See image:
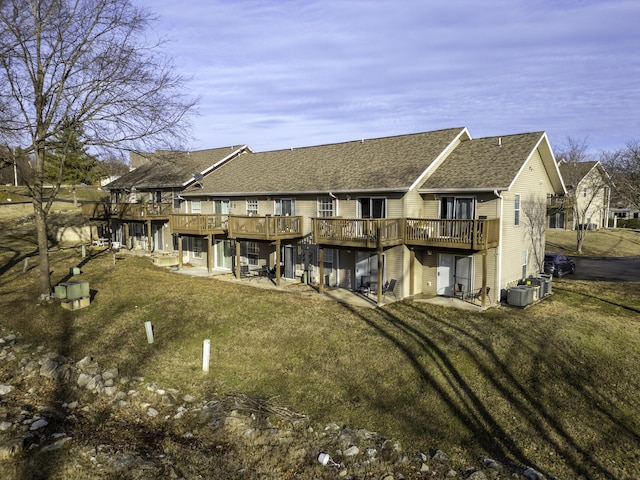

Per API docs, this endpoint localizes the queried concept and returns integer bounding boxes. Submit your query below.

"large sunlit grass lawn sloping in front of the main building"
[0,209,640,479]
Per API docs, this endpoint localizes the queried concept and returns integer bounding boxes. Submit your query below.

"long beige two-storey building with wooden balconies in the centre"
[85,128,565,304]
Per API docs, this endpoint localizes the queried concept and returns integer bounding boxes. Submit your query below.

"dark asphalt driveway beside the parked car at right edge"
[563,257,640,282]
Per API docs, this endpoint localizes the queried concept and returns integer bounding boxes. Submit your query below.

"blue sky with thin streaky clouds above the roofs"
[132,0,640,151]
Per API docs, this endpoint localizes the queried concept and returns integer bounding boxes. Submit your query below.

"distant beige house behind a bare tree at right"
[548,160,611,230]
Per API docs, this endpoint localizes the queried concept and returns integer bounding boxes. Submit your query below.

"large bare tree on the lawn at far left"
[0,0,194,300]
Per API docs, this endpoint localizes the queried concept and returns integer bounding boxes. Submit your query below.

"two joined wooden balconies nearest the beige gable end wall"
[313,218,500,250]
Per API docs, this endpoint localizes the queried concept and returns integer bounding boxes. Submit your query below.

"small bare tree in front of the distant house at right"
[556,137,611,253]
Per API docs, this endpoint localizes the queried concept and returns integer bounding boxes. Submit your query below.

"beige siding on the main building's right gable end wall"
[500,151,554,288]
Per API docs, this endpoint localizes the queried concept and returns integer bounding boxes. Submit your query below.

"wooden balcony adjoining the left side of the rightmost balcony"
[313,217,404,248]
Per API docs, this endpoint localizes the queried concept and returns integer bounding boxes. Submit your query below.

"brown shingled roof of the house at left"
[103,145,250,190]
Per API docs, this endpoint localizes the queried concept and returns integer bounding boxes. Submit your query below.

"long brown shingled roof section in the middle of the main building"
[184,127,468,195]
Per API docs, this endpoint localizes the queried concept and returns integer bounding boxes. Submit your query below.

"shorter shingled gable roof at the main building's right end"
[419,132,564,193]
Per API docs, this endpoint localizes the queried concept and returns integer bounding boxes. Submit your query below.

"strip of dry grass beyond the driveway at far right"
[546,228,640,257]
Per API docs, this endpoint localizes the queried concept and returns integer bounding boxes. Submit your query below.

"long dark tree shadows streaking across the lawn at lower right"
[338,302,640,480]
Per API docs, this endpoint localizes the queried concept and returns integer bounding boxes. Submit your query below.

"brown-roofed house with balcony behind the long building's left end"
[83,146,250,252]
